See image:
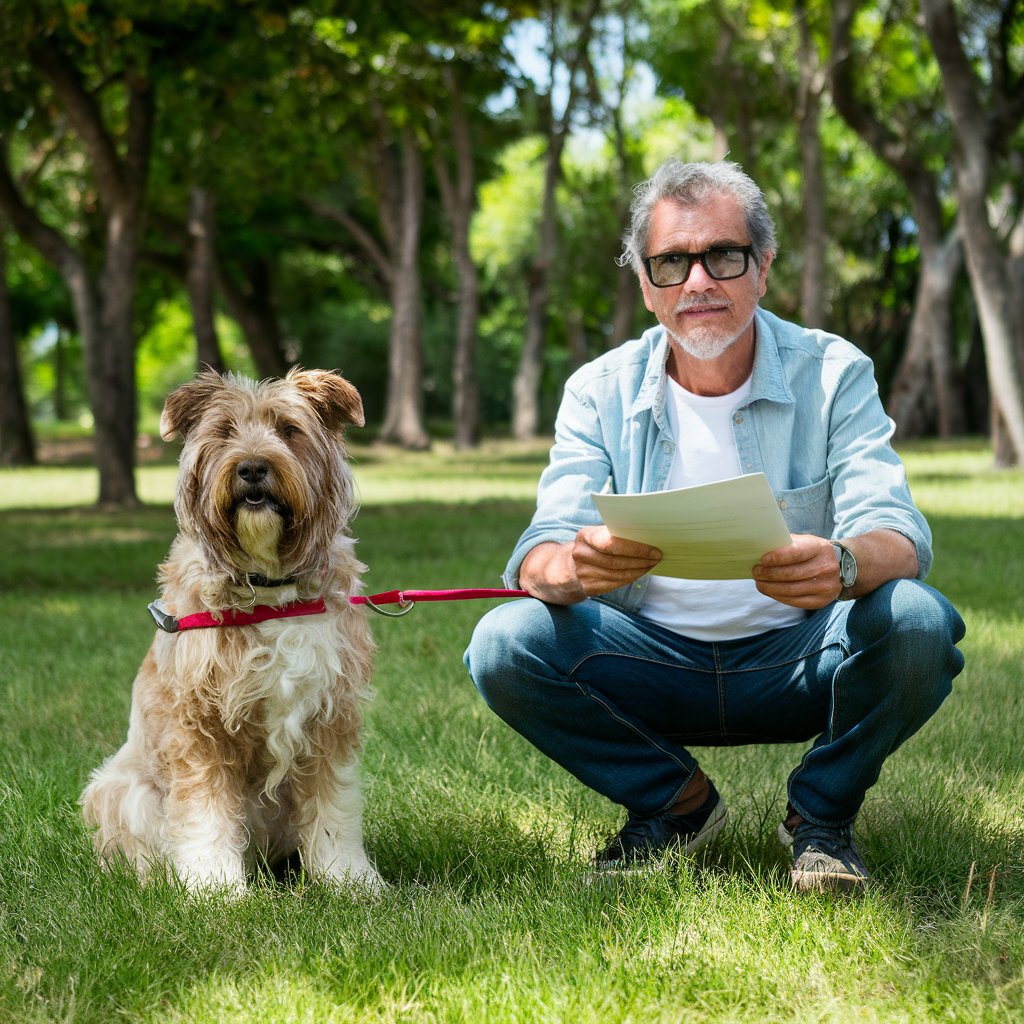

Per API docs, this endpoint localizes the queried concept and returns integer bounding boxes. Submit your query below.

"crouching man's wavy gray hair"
[618,159,777,275]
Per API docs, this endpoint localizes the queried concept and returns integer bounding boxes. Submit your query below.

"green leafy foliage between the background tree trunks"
[0,0,1007,448]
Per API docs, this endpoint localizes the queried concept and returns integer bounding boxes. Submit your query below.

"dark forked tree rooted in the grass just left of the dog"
[0,18,155,507]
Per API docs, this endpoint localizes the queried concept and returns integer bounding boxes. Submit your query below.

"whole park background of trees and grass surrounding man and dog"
[0,0,1024,1024]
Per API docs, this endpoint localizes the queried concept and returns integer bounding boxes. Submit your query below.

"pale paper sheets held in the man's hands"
[594,473,790,580]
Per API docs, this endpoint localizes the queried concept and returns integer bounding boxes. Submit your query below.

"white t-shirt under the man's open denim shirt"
[640,377,806,641]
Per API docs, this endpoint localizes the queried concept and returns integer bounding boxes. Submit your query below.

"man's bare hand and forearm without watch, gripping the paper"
[519,525,662,604]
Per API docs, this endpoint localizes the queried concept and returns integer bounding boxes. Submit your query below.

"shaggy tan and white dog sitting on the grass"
[81,369,382,891]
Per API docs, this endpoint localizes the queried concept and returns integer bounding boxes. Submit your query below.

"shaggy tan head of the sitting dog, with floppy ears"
[160,369,364,577]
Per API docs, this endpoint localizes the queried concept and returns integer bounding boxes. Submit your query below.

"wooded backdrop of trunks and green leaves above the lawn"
[0,0,1024,487]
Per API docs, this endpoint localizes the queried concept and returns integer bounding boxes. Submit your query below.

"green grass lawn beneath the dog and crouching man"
[0,443,1024,1024]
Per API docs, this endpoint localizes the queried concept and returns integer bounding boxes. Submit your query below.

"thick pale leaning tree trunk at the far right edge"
[922,0,1024,463]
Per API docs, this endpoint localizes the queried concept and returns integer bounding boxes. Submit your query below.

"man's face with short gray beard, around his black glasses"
[640,195,771,359]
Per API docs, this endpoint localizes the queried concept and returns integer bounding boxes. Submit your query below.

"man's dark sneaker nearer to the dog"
[594,782,727,871]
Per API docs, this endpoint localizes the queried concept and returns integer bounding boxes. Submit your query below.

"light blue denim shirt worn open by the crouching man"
[504,308,932,611]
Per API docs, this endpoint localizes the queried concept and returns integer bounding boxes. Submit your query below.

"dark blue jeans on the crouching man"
[466,580,965,825]
